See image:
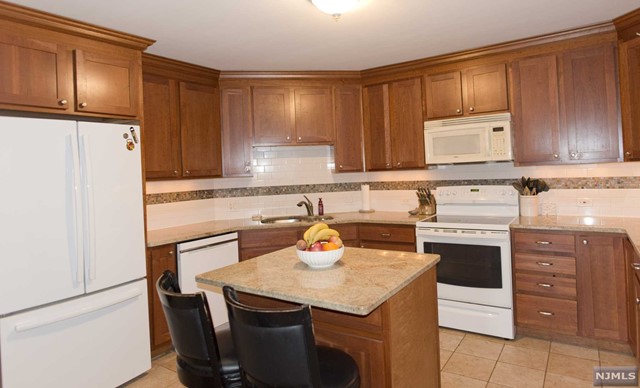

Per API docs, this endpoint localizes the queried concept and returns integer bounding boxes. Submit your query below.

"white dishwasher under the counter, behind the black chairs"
[178,233,238,326]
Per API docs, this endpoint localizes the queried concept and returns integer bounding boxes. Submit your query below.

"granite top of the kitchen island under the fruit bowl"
[196,247,440,316]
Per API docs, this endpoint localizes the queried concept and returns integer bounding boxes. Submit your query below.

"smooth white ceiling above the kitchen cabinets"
[12,0,640,70]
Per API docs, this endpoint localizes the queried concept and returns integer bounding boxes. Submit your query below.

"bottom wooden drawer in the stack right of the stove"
[516,294,578,334]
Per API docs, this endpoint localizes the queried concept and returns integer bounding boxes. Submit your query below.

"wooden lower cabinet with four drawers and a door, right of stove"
[512,230,631,342]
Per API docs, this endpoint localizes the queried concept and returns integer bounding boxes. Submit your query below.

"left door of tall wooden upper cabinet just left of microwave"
[363,84,391,171]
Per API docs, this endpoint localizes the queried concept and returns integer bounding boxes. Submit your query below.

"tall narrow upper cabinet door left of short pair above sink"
[222,87,253,177]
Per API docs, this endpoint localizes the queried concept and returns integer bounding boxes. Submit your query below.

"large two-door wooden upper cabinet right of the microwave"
[511,43,620,164]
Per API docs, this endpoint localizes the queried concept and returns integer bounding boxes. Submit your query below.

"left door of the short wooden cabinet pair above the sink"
[253,87,293,145]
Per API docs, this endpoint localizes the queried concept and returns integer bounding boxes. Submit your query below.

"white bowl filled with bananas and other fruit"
[296,222,344,268]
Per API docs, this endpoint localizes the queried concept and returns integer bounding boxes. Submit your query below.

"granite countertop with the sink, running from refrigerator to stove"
[147,211,426,247]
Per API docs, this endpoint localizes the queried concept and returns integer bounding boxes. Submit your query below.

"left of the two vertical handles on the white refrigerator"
[66,135,84,284]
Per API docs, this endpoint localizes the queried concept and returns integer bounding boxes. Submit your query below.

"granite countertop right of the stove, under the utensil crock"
[510,216,640,255]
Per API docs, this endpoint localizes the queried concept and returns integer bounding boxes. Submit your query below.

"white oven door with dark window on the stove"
[416,228,513,308]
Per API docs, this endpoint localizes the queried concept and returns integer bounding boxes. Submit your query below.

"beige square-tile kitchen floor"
[127,328,636,388]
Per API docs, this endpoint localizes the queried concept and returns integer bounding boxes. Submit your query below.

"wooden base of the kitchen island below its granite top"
[239,267,440,388]
